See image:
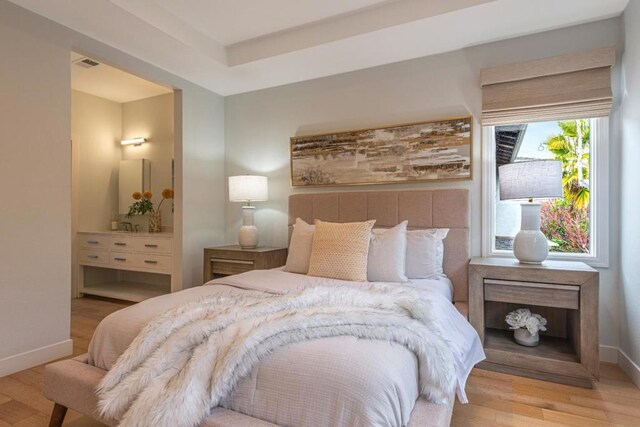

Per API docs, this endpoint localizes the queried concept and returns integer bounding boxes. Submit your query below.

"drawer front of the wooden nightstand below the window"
[484,279,580,310]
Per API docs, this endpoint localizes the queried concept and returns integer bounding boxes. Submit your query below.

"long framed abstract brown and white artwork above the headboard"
[291,117,472,187]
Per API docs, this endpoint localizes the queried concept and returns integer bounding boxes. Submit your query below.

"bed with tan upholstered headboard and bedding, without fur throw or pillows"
[43,189,481,427]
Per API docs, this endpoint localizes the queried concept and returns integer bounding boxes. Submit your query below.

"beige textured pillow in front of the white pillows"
[307,220,376,282]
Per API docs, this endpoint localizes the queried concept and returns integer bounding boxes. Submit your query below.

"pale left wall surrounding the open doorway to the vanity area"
[0,0,224,376]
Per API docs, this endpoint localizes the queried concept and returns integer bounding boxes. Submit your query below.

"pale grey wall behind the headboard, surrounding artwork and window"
[225,18,623,347]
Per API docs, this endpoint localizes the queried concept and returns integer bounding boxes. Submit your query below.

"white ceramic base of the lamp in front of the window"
[513,203,549,264]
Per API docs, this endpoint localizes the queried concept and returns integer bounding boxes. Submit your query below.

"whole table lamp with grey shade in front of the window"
[498,160,562,264]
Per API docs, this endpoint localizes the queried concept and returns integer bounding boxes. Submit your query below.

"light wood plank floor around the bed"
[0,298,640,427]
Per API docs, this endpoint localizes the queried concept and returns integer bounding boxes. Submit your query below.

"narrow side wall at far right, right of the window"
[620,0,640,386]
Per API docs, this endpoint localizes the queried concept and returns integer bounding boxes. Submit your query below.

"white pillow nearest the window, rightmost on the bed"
[405,228,449,279]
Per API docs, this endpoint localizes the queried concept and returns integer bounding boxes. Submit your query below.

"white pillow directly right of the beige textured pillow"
[367,221,407,282]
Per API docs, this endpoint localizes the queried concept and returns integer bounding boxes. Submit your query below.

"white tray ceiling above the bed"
[11,0,629,95]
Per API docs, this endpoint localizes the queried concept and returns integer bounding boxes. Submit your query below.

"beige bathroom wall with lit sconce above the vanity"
[122,93,174,229]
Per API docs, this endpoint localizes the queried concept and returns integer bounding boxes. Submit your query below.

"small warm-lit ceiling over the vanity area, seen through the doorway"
[71,52,173,103]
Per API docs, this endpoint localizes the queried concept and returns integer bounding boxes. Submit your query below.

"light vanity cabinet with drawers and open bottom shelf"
[77,232,173,302]
